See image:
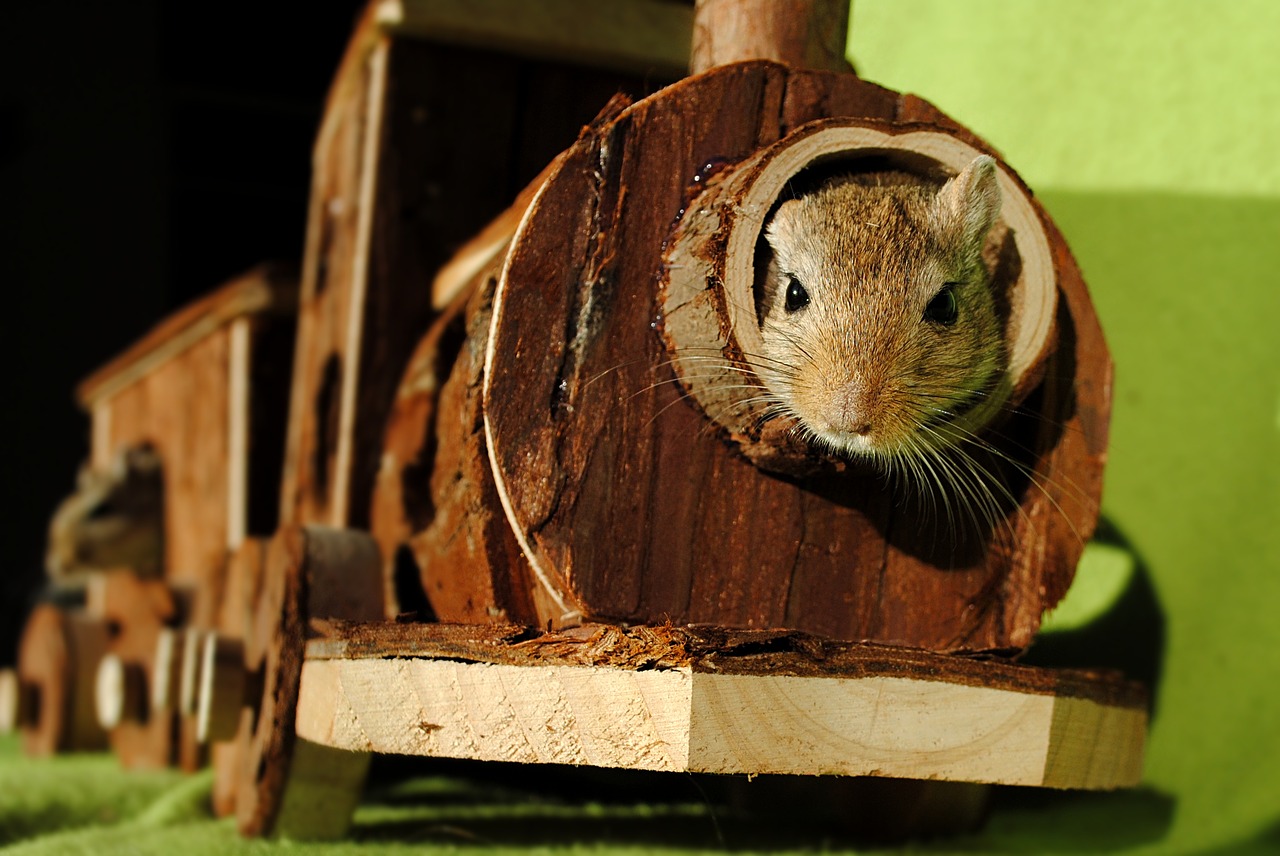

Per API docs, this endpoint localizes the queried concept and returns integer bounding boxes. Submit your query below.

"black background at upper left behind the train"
[0,0,362,665]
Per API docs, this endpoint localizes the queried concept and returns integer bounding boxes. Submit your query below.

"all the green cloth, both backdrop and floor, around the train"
[0,0,1280,856]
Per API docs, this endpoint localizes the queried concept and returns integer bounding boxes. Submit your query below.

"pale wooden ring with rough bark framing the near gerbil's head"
[662,119,1057,473]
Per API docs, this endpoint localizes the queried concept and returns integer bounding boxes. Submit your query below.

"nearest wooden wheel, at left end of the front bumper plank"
[234,526,384,838]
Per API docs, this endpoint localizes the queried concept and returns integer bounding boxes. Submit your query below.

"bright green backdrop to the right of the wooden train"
[850,0,1280,852]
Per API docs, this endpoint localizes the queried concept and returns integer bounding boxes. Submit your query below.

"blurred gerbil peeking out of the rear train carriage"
[45,445,164,589]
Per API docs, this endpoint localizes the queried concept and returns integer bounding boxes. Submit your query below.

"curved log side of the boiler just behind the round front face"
[372,110,628,623]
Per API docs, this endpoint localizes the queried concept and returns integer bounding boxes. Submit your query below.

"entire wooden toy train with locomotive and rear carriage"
[0,0,1146,837]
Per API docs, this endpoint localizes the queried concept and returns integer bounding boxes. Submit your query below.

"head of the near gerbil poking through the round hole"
[756,156,1007,463]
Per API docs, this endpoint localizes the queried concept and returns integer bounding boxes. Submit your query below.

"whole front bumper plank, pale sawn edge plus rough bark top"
[297,624,1147,789]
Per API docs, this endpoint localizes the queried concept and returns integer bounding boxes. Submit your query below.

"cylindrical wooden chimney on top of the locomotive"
[690,0,852,74]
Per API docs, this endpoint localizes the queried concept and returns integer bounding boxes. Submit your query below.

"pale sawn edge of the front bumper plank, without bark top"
[297,647,1146,788]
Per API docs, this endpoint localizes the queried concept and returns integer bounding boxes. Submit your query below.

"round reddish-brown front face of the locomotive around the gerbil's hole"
[481,61,1111,651]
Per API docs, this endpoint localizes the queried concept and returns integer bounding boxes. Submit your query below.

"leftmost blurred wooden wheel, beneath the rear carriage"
[10,605,110,756]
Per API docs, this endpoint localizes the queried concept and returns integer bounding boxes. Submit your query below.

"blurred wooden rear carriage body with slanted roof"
[76,265,297,589]
